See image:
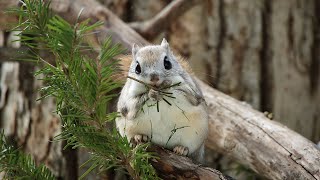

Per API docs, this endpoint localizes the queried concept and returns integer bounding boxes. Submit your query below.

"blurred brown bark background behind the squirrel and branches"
[0,0,320,179]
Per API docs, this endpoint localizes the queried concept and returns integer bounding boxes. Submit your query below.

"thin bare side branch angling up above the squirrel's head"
[130,0,201,40]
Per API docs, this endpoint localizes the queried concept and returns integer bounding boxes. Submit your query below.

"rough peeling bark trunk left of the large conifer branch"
[0,40,63,177]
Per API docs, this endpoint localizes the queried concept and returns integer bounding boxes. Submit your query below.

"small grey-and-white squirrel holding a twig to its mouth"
[116,39,208,162]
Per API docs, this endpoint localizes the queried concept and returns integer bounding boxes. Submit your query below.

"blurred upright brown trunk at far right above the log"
[269,0,320,141]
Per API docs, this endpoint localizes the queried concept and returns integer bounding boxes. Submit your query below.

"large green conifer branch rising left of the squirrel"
[4,0,157,179]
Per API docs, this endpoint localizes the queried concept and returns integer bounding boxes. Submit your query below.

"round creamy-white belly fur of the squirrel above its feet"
[116,91,208,154]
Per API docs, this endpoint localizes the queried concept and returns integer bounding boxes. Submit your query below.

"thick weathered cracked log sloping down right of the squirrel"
[199,81,320,179]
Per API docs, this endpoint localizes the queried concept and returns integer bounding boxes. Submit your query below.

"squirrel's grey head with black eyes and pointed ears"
[129,39,183,86]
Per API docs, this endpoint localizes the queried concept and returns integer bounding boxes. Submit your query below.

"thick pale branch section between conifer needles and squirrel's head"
[52,0,148,50]
